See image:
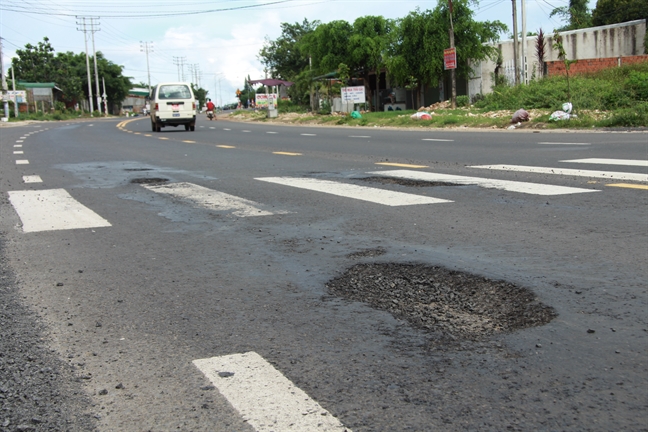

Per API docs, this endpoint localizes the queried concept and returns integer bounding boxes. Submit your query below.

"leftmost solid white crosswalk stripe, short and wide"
[9,189,111,232]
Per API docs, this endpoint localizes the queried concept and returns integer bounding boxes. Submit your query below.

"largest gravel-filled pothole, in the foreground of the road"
[327,263,557,340]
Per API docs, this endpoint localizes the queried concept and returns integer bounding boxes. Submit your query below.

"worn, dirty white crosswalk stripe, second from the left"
[142,183,286,217]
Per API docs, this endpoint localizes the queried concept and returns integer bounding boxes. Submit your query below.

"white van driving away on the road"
[149,82,196,132]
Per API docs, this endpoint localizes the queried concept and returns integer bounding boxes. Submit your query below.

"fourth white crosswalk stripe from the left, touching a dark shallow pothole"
[368,170,600,195]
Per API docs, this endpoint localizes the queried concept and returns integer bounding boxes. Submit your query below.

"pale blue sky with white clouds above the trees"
[0,0,596,103]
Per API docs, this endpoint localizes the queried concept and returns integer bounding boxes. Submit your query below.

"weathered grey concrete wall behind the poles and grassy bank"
[478,20,646,97]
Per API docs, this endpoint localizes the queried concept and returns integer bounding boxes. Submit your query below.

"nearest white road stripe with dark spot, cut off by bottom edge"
[193,351,351,432]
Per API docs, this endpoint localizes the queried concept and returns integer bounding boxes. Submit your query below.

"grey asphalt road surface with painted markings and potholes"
[0,118,648,431]
